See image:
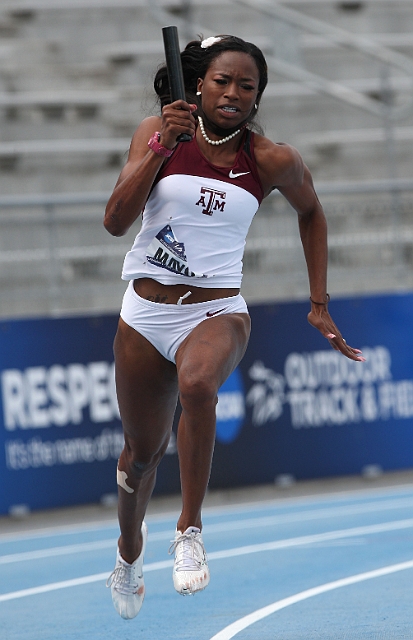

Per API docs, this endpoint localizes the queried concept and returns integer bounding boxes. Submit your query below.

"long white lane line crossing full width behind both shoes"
[0,518,413,602]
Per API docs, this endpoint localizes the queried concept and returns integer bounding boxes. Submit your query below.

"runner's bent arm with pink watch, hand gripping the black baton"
[103,100,195,236]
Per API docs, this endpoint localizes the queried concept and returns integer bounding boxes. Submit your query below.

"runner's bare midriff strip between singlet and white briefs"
[133,278,239,304]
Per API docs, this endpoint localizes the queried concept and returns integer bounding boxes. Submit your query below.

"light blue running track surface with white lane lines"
[0,486,413,640]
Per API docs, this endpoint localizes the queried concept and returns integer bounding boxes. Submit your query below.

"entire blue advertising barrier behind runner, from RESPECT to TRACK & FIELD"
[0,294,413,513]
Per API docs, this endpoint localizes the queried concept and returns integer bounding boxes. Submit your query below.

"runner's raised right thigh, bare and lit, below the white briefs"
[176,313,251,390]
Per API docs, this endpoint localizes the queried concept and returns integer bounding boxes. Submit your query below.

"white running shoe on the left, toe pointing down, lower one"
[106,522,148,620]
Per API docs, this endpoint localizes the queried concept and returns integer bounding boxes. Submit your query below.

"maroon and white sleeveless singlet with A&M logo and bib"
[122,130,263,288]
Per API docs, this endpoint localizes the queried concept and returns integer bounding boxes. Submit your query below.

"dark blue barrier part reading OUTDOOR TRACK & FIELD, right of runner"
[210,295,413,487]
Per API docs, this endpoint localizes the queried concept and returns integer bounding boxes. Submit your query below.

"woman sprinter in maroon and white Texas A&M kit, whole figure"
[104,36,363,618]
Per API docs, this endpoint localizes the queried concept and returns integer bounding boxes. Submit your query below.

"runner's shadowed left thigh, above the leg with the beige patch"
[114,319,178,440]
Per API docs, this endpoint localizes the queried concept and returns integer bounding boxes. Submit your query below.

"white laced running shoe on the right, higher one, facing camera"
[169,527,209,596]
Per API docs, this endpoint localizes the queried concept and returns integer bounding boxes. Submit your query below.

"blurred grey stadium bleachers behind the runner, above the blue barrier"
[0,0,413,317]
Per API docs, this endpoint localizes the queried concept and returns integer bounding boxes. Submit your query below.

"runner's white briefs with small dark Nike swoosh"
[120,280,248,362]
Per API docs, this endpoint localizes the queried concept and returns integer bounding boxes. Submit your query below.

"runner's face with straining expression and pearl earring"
[198,51,259,128]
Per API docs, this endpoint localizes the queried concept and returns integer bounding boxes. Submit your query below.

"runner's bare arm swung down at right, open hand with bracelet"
[256,145,364,361]
